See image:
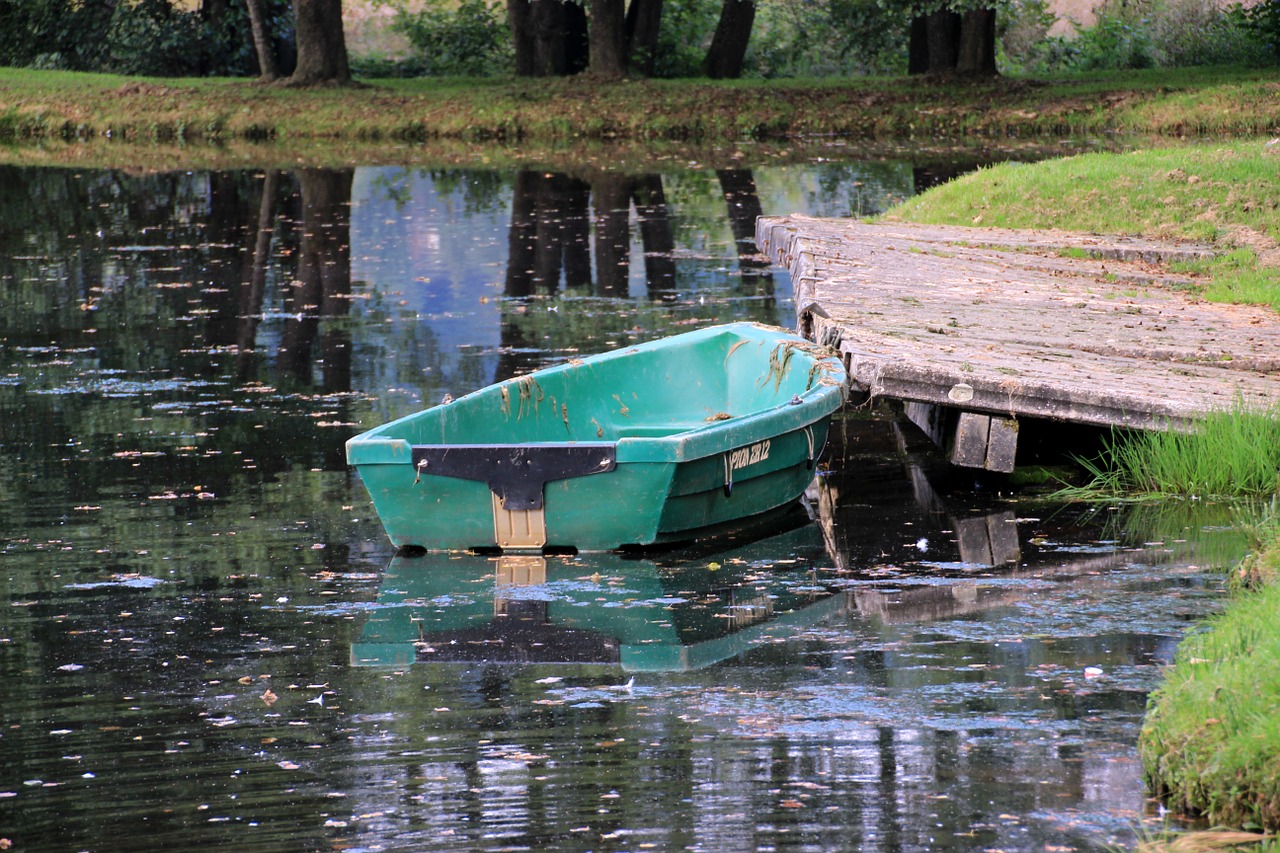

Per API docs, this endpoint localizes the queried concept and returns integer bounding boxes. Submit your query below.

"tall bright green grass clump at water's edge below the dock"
[1080,405,1280,497]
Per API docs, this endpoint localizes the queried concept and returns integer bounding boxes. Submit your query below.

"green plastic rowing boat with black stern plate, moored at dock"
[347,323,845,551]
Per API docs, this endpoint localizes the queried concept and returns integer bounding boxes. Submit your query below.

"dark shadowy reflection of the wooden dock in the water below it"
[809,415,1238,625]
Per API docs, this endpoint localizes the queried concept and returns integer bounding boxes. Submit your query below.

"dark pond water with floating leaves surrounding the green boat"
[0,160,1245,850]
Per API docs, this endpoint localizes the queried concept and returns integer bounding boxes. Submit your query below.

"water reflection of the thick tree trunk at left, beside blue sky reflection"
[280,169,355,391]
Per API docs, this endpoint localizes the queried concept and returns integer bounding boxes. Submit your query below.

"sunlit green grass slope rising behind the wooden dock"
[886,138,1280,310]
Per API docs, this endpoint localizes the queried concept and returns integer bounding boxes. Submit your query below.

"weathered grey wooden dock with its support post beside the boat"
[755,216,1280,471]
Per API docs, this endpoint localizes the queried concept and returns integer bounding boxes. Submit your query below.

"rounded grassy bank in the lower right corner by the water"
[1139,505,1280,831]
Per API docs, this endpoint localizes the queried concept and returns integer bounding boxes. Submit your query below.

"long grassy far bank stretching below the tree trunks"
[0,69,1280,149]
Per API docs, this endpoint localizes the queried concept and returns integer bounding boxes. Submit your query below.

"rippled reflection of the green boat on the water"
[351,524,849,671]
